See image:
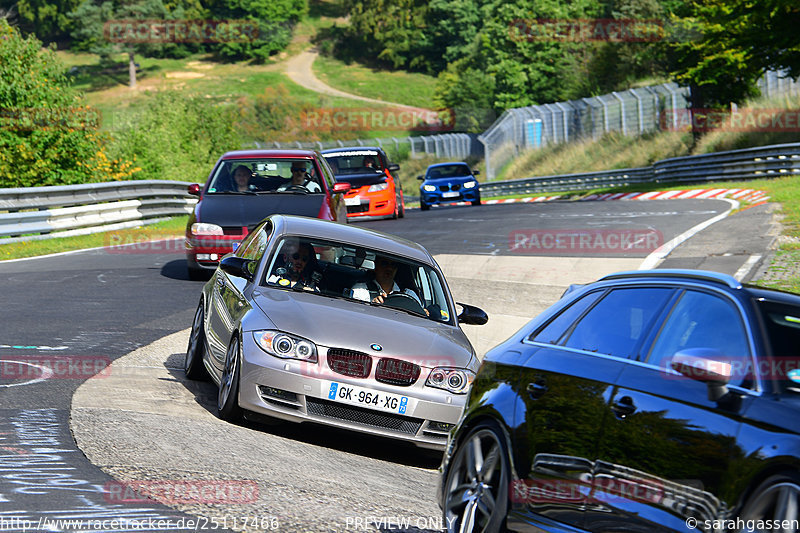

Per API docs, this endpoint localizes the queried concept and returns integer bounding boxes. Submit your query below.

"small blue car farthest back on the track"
[417,163,481,211]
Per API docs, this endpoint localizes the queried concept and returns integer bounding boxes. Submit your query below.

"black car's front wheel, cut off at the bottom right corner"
[739,472,800,524]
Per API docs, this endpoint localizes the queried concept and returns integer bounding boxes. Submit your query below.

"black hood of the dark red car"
[197,193,325,227]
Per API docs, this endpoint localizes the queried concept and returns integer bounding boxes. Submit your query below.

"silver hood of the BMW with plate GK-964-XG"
[253,287,474,368]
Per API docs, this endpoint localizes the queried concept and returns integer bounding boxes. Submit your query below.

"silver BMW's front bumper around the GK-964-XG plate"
[239,333,467,450]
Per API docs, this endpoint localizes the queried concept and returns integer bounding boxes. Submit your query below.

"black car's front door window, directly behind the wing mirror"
[647,291,750,376]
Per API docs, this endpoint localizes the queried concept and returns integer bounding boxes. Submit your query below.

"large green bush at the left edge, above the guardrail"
[0,19,138,187]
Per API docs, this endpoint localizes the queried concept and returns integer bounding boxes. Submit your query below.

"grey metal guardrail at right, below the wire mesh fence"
[481,143,800,197]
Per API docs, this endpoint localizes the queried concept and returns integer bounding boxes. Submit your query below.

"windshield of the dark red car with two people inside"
[208,158,322,194]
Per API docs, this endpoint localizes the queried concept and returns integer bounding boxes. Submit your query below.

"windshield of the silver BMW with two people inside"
[264,237,453,324]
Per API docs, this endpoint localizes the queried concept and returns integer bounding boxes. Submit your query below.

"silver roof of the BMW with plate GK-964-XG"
[269,215,435,265]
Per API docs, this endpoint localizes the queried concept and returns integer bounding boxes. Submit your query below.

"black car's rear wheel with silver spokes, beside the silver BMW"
[444,423,511,533]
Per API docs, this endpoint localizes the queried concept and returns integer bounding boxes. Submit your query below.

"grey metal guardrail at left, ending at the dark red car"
[0,180,197,244]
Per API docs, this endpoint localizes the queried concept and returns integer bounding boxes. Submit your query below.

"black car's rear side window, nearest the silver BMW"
[565,288,673,359]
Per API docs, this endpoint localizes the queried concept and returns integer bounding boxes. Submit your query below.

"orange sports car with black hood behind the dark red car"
[322,146,405,219]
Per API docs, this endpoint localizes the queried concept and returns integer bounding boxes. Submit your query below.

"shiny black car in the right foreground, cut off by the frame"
[439,270,800,533]
